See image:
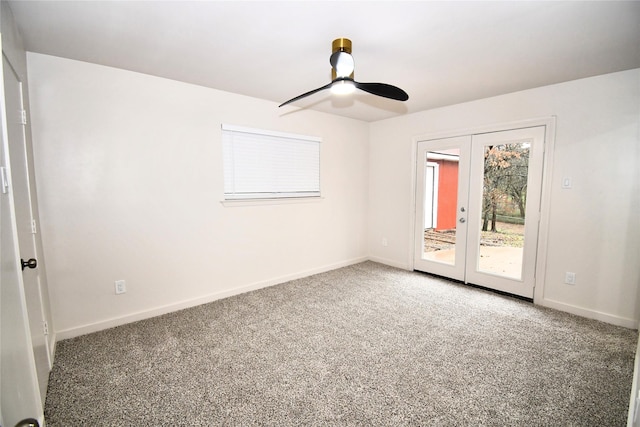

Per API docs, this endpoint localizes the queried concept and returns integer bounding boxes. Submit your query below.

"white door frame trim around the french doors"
[407,116,556,303]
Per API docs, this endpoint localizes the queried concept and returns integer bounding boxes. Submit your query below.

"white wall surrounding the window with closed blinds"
[28,53,369,338]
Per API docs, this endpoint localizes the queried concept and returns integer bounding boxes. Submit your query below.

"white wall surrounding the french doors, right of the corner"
[369,69,640,327]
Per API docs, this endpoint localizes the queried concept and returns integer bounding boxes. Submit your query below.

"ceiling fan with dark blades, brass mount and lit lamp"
[279,38,409,107]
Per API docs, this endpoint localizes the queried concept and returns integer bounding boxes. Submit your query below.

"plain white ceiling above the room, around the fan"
[9,0,640,121]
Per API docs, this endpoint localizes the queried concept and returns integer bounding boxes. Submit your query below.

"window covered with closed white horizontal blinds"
[222,124,321,200]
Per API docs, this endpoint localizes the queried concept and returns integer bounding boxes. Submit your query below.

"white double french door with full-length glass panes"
[414,126,545,298]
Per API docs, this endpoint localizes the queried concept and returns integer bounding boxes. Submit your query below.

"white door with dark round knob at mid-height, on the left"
[3,56,51,404]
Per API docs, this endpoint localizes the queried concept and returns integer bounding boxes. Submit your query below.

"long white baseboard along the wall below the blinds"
[55,257,369,340]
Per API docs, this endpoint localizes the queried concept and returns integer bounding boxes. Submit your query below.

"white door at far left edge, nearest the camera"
[0,58,43,426]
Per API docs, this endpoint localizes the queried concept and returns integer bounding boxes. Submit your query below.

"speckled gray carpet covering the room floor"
[45,262,637,427]
